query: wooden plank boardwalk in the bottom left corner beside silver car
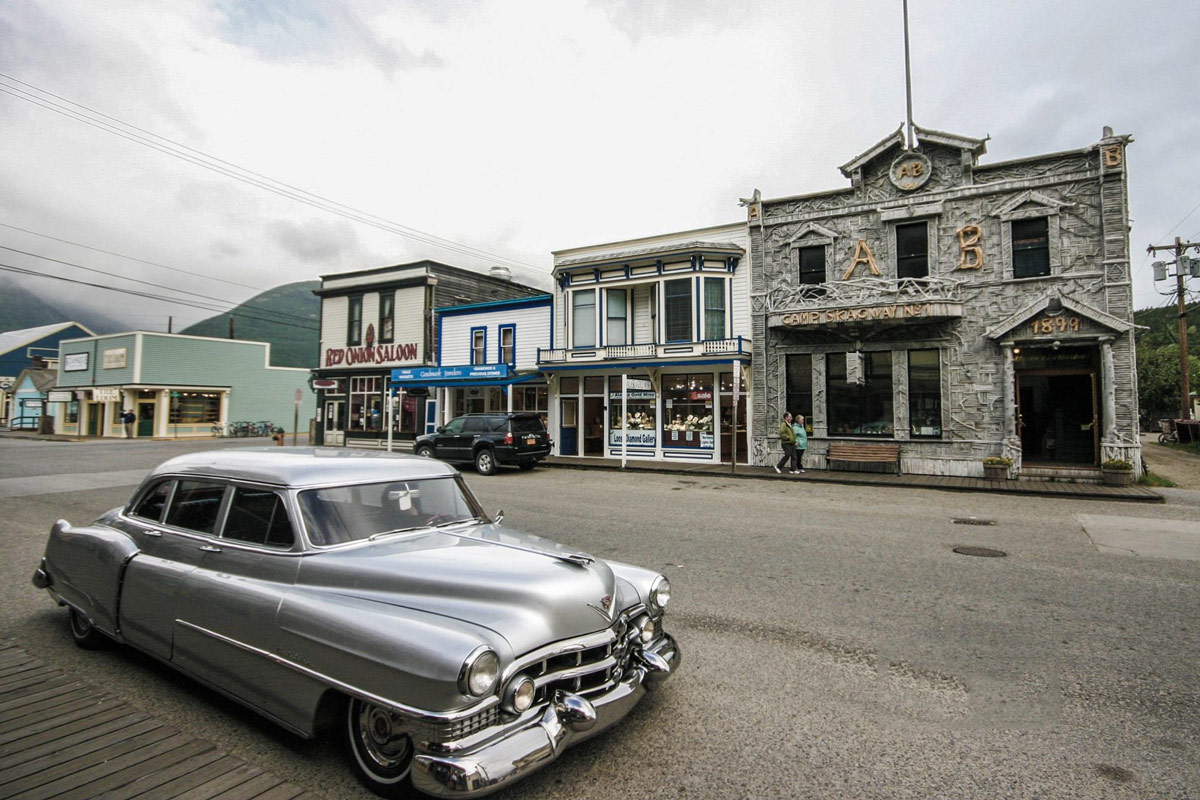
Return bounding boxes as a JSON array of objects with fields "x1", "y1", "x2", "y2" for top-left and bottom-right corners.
[{"x1": 0, "y1": 639, "x2": 322, "y2": 800}]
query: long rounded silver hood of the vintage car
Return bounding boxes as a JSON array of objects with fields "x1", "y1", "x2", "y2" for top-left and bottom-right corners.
[{"x1": 298, "y1": 524, "x2": 619, "y2": 655}]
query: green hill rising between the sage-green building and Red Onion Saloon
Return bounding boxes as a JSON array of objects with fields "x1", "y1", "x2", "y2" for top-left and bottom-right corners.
[{"x1": 180, "y1": 281, "x2": 320, "y2": 368}]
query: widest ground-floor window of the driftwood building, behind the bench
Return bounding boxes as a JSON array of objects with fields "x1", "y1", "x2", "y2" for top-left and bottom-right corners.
[{"x1": 826, "y1": 351, "x2": 894, "y2": 437}]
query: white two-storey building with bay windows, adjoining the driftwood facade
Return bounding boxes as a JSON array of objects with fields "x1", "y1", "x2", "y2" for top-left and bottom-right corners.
[{"x1": 538, "y1": 223, "x2": 751, "y2": 463}]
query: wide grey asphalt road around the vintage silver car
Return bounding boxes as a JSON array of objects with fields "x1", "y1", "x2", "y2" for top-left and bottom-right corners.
[{"x1": 0, "y1": 440, "x2": 1200, "y2": 800}]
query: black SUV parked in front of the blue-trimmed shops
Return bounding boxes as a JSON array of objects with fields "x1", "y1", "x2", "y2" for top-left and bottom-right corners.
[{"x1": 413, "y1": 413, "x2": 550, "y2": 475}]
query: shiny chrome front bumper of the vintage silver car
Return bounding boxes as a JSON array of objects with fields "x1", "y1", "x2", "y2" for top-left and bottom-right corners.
[{"x1": 413, "y1": 636, "x2": 680, "y2": 798}]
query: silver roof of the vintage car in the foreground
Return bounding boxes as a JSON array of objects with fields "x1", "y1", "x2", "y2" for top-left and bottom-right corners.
[{"x1": 141, "y1": 447, "x2": 457, "y2": 488}]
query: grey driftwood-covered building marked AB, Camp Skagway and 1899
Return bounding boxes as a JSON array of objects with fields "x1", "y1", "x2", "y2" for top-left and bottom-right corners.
[{"x1": 744, "y1": 127, "x2": 1140, "y2": 480}]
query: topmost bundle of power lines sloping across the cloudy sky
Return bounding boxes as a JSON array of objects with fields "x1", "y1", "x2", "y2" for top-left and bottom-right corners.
[{"x1": 0, "y1": 73, "x2": 546, "y2": 283}]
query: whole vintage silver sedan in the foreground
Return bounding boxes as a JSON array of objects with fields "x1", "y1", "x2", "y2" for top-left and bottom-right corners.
[{"x1": 34, "y1": 449, "x2": 680, "y2": 798}]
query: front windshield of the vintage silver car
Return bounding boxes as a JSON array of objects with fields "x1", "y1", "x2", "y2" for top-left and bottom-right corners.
[{"x1": 300, "y1": 477, "x2": 481, "y2": 547}]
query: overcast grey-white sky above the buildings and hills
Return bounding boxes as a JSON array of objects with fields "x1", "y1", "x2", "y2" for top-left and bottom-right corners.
[{"x1": 0, "y1": 0, "x2": 1200, "y2": 330}]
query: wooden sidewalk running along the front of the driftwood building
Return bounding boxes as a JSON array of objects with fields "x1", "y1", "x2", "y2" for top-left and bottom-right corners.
[{"x1": 542, "y1": 456, "x2": 1164, "y2": 503}]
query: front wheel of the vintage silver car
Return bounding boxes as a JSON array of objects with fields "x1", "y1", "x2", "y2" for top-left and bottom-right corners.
[{"x1": 346, "y1": 699, "x2": 418, "y2": 798}]
